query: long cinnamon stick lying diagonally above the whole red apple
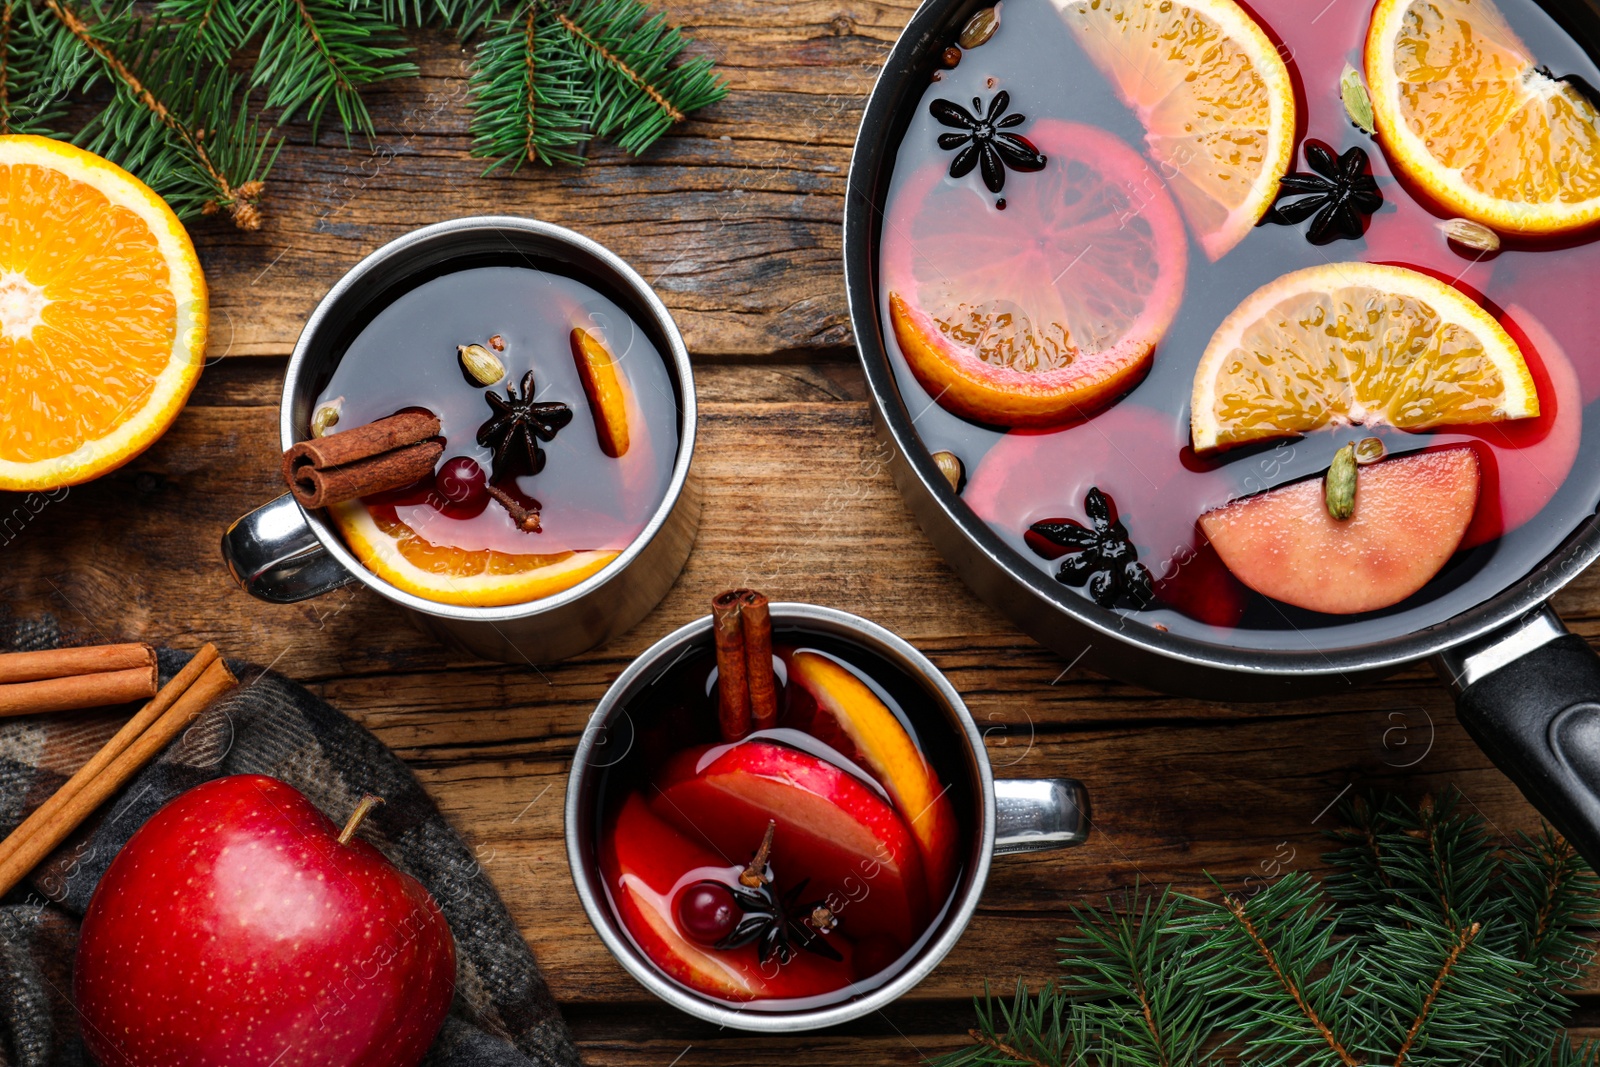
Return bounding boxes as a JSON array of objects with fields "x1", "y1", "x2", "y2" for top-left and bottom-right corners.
[{"x1": 0, "y1": 659, "x2": 238, "y2": 896}]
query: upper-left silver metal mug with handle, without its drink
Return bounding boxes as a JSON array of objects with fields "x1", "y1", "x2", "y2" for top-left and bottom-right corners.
[{"x1": 222, "y1": 216, "x2": 701, "y2": 662}]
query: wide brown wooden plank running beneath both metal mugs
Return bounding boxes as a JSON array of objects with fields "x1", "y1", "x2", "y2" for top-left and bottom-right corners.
[{"x1": 0, "y1": 360, "x2": 1600, "y2": 1036}]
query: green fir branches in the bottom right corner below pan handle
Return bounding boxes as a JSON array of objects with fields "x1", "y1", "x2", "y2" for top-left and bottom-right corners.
[{"x1": 938, "y1": 793, "x2": 1600, "y2": 1067}]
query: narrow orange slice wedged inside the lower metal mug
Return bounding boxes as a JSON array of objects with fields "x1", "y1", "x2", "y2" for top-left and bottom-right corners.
[{"x1": 781, "y1": 649, "x2": 958, "y2": 904}]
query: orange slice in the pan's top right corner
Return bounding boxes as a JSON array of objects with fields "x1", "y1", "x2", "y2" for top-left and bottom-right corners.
[{"x1": 1366, "y1": 0, "x2": 1600, "y2": 234}]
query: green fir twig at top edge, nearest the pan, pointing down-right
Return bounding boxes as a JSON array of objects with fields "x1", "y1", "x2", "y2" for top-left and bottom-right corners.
[{"x1": 555, "y1": 0, "x2": 728, "y2": 155}]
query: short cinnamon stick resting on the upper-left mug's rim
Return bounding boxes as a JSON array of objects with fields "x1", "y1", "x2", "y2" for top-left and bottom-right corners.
[{"x1": 283, "y1": 411, "x2": 445, "y2": 507}]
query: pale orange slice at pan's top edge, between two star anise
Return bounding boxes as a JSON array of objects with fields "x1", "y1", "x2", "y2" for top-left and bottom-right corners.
[{"x1": 1056, "y1": 0, "x2": 1294, "y2": 261}]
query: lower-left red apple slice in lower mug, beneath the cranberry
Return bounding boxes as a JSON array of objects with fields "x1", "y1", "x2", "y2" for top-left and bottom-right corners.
[{"x1": 600, "y1": 793, "x2": 854, "y2": 1001}]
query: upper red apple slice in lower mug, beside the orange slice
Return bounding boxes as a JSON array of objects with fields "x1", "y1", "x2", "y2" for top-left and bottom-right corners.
[{"x1": 650, "y1": 741, "x2": 928, "y2": 945}]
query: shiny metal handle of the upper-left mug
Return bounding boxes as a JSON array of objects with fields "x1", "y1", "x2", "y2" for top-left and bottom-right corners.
[{"x1": 222, "y1": 493, "x2": 355, "y2": 603}]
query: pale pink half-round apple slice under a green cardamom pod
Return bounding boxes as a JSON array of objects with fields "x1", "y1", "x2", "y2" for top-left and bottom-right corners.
[{"x1": 1200, "y1": 448, "x2": 1480, "y2": 614}]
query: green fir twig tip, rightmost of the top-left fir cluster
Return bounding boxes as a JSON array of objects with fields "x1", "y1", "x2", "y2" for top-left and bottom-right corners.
[{"x1": 246, "y1": 0, "x2": 418, "y2": 141}]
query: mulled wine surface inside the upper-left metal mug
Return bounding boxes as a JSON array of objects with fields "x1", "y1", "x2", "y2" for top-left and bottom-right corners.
[{"x1": 314, "y1": 266, "x2": 678, "y2": 553}]
